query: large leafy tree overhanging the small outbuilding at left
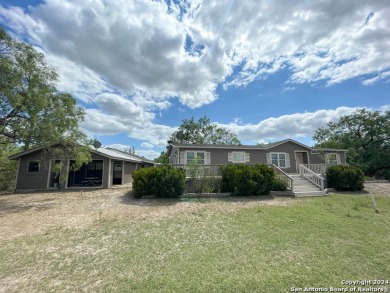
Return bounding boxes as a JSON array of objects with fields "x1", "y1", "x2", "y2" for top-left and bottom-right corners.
[{"x1": 0, "y1": 29, "x2": 86, "y2": 149}]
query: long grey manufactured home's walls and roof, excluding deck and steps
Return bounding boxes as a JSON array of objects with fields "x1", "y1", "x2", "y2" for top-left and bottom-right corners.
[{"x1": 168, "y1": 139, "x2": 347, "y2": 173}]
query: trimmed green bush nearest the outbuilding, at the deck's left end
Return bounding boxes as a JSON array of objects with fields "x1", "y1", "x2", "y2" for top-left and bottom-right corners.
[{"x1": 133, "y1": 166, "x2": 186, "y2": 198}]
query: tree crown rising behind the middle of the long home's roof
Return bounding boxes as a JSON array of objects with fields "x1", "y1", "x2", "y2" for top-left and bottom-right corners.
[{"x1": 170, "y1": 116, "x2": 241, "y2": 145}]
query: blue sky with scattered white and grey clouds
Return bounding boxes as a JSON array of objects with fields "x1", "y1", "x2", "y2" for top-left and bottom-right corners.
[{"x1": 0, "y1": 0, "x2": 390, "y2": 158}]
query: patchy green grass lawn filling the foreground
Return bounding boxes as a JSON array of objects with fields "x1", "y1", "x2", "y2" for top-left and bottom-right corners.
[{"x1": 0, "y1": 195, "x2": 390, "y2": 292}]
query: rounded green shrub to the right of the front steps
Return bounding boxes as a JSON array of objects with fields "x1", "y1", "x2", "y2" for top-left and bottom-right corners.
[{"x1": 326, "y1": 165, "x2": 364, "y2": 191}]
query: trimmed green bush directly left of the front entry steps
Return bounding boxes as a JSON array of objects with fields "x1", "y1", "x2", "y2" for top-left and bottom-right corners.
[{"x1": 221, "y1": 164, "x2": 275, "y2": 196}]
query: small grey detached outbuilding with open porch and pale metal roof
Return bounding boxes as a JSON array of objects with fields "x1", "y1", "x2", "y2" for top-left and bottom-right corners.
[{"x1": 9, "y1": 146, "x2": 154, "y2": 192}]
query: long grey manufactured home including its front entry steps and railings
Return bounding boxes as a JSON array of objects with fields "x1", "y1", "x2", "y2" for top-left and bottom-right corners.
[{"x1": 168, "y1": 139, "x2": 347, "y2": 193}]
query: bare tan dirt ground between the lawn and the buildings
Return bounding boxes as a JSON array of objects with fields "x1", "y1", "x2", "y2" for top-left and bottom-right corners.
[{"x1": 0, "y1": 183, "x2": 390, "y2": 240}]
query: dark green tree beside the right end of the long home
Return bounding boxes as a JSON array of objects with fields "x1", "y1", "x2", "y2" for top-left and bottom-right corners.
[{"x1": 313, "y1": 109, "x2": 390, "y2": 176}]
